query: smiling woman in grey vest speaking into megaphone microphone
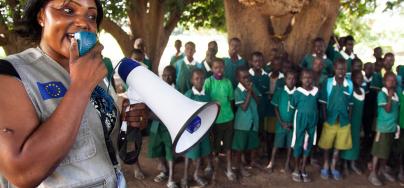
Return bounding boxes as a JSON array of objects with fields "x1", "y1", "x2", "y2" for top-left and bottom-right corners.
[{"x1": 0, "y1": 0, "x2": 146, "y2": 187}]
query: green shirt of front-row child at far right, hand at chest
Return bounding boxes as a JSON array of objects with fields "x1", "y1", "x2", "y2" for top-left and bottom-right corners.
[{"x1": 376, "y1": 87, "x2": 399, "y2": 133}]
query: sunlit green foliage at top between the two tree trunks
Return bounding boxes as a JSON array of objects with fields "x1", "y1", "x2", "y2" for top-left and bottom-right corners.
[{"x1": 179, "y1": 0, "x2": 226, "y2": 32}]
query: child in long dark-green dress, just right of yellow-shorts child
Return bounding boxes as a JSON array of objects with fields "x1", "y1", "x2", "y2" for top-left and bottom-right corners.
[{"x1": 341, "y1": 70, "x2": 365, "y2": 175}]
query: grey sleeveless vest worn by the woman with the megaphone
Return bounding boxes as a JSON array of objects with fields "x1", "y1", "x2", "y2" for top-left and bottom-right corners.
[{"x1": 6, "y1": 48, "x2": 119, "y2": 188}]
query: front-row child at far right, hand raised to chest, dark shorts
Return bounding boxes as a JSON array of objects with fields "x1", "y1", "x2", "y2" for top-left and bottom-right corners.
[{"x1": 368, "y1": 72, "x2": 400, "y2": 186}]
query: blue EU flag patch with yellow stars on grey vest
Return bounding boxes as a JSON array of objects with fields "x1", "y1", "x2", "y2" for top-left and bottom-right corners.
[{"x1": 37, "y1": 82, "x2": 67, "y2": 100}]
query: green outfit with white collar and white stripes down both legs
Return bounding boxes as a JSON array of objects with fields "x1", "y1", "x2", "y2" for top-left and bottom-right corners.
[{"x1": 291, "y1": 87, "x2": 319, "y2": 157}]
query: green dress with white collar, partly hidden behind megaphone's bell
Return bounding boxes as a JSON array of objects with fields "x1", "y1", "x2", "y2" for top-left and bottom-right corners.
[{"x1": 185, "y1": 87, "x2": 212, "y2": 160}]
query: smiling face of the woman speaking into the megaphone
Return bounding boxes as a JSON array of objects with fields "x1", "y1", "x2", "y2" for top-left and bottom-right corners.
[{"x1": 38, "y1": 0, "x2": 97, "y2": 60}]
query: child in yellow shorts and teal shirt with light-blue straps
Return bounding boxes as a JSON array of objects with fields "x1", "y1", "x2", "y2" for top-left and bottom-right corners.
[{"x1": 318, "y1": 58, "x2": 353, "y2": 180}]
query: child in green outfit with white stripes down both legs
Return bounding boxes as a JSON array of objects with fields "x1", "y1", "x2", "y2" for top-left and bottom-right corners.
[{"x1": 291, "y1": 69, "x2": 319, "y2": 182}]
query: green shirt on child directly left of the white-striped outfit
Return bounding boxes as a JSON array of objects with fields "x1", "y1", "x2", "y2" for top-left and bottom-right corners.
[{"x1": 271, "y1": 86, "x2": 296, "y2": 123}]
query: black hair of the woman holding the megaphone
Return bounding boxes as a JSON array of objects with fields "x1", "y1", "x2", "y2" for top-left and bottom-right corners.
[{"x1": 15, "y1": 0, "x2": 104, "y2": 41}]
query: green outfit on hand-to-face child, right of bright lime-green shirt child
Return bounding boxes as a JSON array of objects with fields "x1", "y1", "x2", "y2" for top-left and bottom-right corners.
[{"x1": 232, "y1": 83, "x2": 261, "y2": 151}]
